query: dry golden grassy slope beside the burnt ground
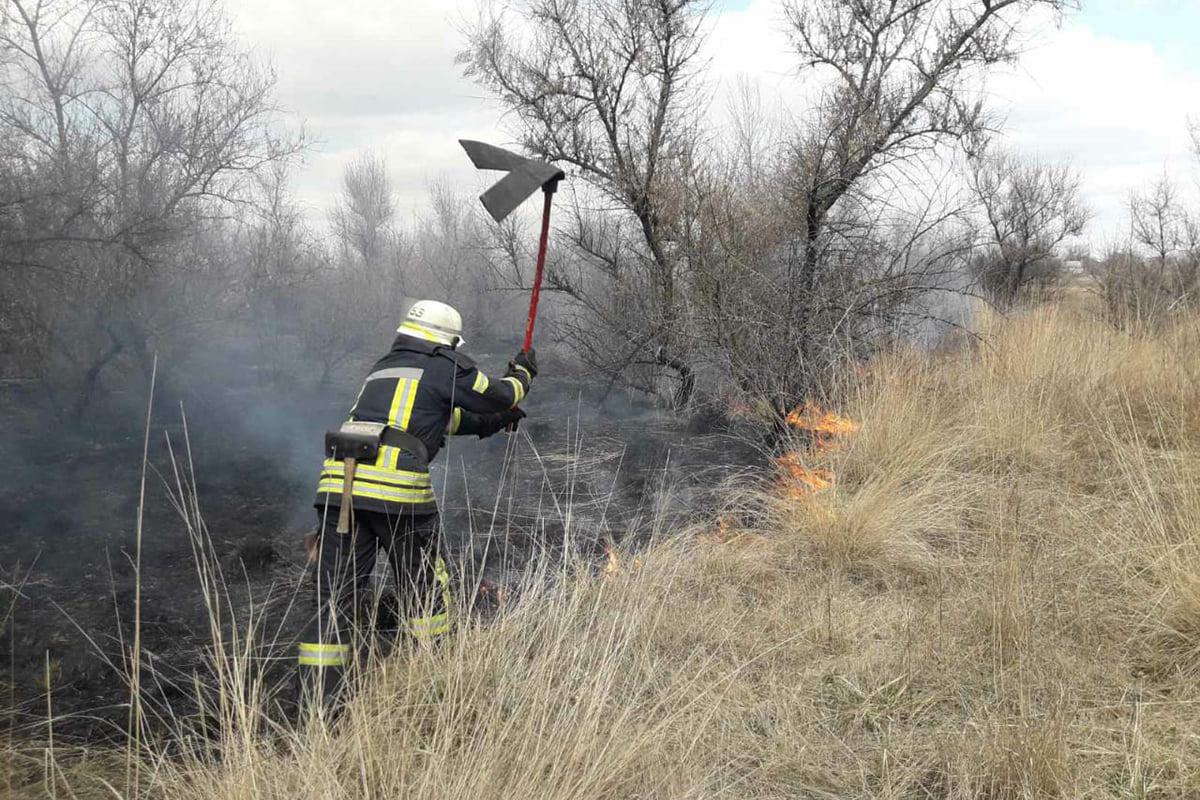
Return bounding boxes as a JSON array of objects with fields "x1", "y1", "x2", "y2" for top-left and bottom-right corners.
[{"x1": 11, "y1": 307, "x2": 1200, "y2": 800}]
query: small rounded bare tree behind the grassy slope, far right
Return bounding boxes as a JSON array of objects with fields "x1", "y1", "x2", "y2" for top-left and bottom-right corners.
[{"x1": 968, "y1": 150, "x2": 1087, "y2": 303}]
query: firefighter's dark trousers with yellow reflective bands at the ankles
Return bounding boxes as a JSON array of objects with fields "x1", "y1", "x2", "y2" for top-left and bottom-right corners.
[{"x1": 299, "y1": 509, "x2": 450, "y2": 708}]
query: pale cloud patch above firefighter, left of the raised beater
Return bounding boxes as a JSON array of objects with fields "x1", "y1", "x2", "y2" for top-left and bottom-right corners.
[{"x1": 228, "y1": 0, "x2": 504, "y2": 219}]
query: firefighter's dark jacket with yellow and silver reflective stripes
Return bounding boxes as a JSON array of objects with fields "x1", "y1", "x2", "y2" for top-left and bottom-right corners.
[{"x1": 316, "y1": 333, "x2": 530, "y2": 513}]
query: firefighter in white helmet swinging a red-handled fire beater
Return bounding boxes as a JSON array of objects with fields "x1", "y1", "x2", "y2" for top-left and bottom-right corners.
[{"x1": 299, "y1": 300, "x2": 538, "y2": 706}]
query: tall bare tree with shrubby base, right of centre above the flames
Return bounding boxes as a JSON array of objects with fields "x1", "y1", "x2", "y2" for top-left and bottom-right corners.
[{"x1": 700, "y1": 0, "x2": 1074, "y2": 416}]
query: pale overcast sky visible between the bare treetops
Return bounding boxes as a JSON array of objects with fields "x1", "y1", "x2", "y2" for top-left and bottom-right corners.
[{"x1": 227, "y1": 0, "x2": 1200, "y2": 243}]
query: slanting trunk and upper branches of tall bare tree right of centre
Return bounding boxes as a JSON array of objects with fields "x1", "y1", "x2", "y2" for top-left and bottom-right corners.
[{"x1": 785, "y1": 0, "x2": 1073, "y2": 341}]
